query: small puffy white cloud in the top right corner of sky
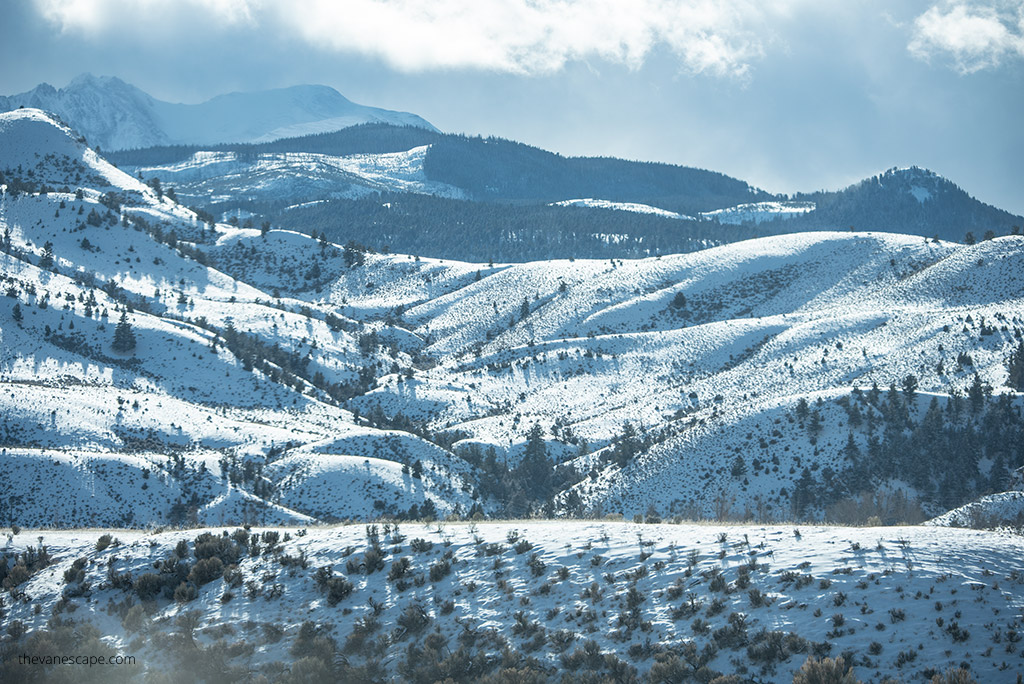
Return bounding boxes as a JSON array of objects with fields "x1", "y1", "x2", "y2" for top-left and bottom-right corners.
[{"x1": 908, "y1": 0, "x2": 1024, "y2": 74}]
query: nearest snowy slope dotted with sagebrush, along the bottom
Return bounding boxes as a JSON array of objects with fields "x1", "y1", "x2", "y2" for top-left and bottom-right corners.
[{"x1": 0, "y1": 521, "x2": 1024, "y2": 682}]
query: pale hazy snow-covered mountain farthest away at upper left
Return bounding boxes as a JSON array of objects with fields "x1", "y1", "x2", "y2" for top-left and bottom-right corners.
[{"x1": 0, "y1": 74, "x2": 435, "y2": 149}]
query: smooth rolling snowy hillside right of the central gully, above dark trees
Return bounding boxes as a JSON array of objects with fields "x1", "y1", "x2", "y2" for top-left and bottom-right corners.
[{"x1": 307, "y1": 233, "x2": 1024, "y2": 518}]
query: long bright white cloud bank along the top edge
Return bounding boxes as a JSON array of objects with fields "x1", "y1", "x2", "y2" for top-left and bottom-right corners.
[{"x1": 29, "y1": 0, "x2": 806, "y2": 76}]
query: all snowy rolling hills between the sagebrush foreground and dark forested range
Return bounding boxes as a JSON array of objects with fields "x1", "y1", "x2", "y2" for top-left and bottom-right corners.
[{"x1": 0, "y1": 110, "x2": 1024, "y2": 525}]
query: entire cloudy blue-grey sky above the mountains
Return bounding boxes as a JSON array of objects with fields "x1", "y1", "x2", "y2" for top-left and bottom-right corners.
[{"x1": 6, "y1": 0, "x2": 1024, "y2": 214}]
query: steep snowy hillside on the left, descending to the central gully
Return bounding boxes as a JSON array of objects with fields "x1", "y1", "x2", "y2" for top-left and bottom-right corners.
[{"x1": 0, "y1": 110, "x2": 471, "y2": 525}]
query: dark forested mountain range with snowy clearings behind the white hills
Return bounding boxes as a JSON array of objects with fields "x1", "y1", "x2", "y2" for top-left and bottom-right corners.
[{"x1": 108, "y1": 124, "x2": 1024, "y2": 254}]
